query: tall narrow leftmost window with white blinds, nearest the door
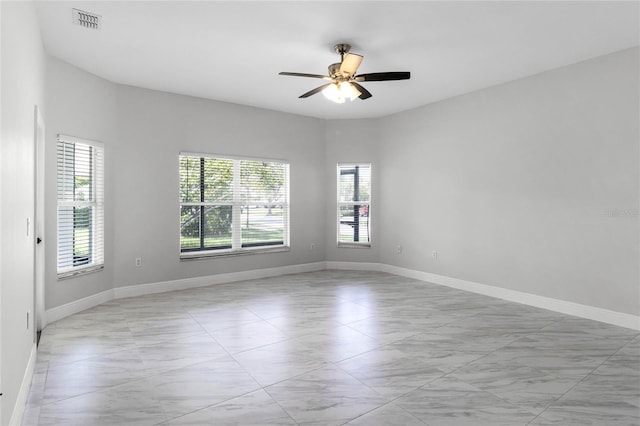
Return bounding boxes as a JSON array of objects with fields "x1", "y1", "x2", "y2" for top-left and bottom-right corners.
[{"x1": 57, "y1": 135, "x2": 104, "y2": 277}]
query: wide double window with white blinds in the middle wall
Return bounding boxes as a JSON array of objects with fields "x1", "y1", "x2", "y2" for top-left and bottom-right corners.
[{"x1": 180, "y1": 153, "x2": 289, "y2": 257}]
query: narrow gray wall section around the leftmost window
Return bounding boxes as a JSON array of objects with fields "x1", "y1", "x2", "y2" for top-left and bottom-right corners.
[{"x1": 44, "y1": 57, "x2": 118, "y2": 309}]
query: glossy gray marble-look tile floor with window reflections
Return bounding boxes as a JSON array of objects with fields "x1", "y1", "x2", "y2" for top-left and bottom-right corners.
[{"x1": 23, "y1": 271, "x2": 640, "y2": 426}]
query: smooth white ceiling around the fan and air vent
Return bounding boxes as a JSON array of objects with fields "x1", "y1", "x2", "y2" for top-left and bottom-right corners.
[{"x1": 37, "y1": 1, "x2": 640, "y2": 118}]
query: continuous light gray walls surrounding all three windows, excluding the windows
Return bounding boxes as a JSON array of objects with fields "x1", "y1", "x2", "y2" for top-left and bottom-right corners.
[{"x1": 42, "y1": 49, "x2": 640, "y2": 315}]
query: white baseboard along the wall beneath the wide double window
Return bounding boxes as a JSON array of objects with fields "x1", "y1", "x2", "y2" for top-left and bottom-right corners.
[{"x1": 113, "y1": 262, "x2": 326, "y2": 299}]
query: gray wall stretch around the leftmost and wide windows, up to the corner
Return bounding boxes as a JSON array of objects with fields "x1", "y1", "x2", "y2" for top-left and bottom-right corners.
[{"x1": 46, "y1": 58, "x2": 325, "y2": 309}]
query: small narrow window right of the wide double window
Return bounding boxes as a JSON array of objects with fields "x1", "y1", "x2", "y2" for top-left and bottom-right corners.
[{"x1": 338, "y1": 164, "x2": 371, "y2": 247}]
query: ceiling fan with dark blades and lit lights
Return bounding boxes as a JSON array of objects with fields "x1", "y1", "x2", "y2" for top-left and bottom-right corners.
[{"x1": 279, "y1": 43, "x2": 411, "y2": 103}]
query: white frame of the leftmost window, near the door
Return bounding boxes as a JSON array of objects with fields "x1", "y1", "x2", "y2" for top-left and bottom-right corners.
[{"x1": 56, "y1": 134, "x2": 105, "y2": 279}]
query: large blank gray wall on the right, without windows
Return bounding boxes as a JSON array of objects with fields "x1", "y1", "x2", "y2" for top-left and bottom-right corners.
[{"x1": 379, "y1": 48, "x2": 640, "y2": 315}]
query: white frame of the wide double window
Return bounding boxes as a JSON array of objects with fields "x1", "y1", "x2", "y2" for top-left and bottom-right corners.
[{"x1": 178, "y1": 152, "x2": 291, "y2": 260}]
